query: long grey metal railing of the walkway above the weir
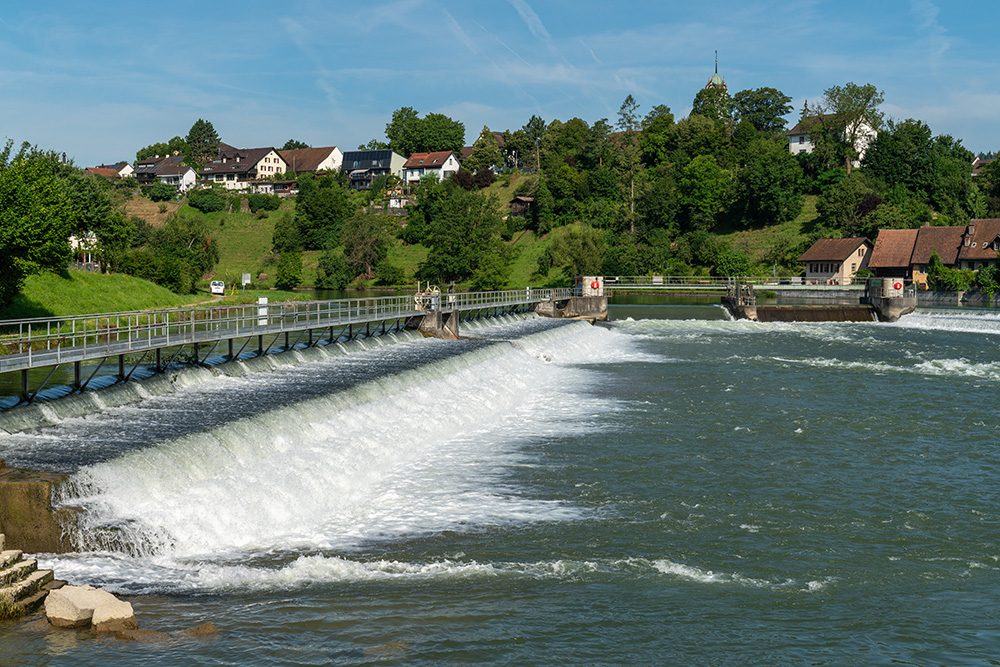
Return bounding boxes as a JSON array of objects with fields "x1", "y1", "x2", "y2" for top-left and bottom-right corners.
[{"x1": 0, "y1": 288, "x2": 572, "y2": 372}]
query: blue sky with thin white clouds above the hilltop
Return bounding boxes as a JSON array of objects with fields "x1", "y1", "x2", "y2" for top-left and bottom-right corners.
[{"x1": 0, "y1": 0, "x2": 1000, "y2": 167}]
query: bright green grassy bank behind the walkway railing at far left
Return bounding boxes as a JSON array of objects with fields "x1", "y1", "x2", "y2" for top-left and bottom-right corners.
[{"x1": 3, "y1": 270, "x2": 193, "y2": 319}]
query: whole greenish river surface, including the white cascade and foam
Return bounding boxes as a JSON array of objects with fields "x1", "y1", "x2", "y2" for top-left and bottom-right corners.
[{"x1": 0, "y1": 305, "x2": 1000, "y2": 666}]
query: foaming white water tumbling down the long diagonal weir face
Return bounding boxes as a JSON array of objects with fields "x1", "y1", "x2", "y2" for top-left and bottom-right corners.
[{"x1": 49, "y1": 325, "x2": 632, "y2": 590}]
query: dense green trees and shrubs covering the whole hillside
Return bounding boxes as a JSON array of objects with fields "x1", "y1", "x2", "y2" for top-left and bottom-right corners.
[{"x1": 0, "y1": 83, "x2": 1000, "y2": 306}]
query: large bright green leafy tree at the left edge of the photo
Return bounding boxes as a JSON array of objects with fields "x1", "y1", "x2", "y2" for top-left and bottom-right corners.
[{"x1": 0, "y1": 141, "x2": 74, "y2": 308}]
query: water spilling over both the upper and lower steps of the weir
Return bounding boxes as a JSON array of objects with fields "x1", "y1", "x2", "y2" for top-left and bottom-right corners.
[{"x1": 15, "y1": 316, "x2": 614, "y2": 587}]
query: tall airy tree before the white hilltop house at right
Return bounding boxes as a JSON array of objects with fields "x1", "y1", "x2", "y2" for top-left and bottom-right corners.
[{"x1": 801, "y1": 82, "x2": 885, "y2": 174}]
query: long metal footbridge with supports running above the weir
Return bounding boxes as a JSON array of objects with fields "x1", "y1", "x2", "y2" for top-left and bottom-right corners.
[{"x1": 0, "y1": 287, "x2": 584, "y2": 407}]
